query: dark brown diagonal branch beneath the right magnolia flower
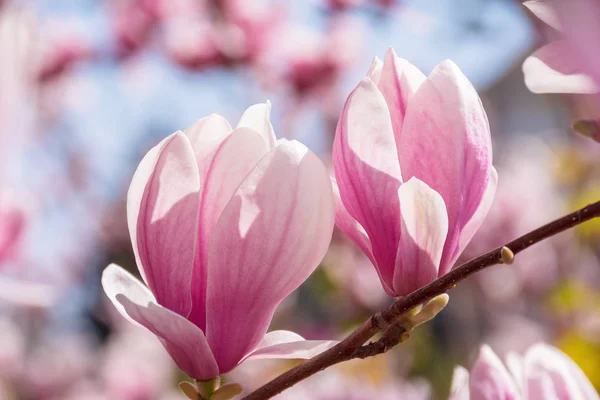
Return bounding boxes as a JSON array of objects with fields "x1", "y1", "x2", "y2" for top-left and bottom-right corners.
[{"x1": 242, "y1": 201, "x2": 600, "y2": 400}]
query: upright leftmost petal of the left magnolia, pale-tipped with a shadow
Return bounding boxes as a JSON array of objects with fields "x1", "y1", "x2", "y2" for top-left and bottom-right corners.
[{"x1": 127, "y1": 132, "x2": 200, "y2": 316}]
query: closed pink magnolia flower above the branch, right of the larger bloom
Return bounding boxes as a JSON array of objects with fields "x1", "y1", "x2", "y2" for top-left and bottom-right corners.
[{"x1": 333, "y1": 49, "x2": 497, "y2": 296}]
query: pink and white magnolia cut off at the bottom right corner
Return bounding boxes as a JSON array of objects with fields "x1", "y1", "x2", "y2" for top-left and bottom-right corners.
[{"x1": 450, "y1": 343, "x2": 600, "y2": 400}]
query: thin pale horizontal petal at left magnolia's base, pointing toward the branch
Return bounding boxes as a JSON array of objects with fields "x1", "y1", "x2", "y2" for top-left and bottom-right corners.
[{"x1": 242, "y1": 340, "x2": 339, "y2": 362}]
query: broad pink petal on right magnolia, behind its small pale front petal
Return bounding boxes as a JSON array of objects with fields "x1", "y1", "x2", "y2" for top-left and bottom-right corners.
[{"x1": 398, "y1": 61, "x2": 492, "y2": 275}]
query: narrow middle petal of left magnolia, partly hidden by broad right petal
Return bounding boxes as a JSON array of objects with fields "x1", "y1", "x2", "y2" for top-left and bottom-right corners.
[{"x1": 189, "y1": 128, "x2": 267, "y2": 329}]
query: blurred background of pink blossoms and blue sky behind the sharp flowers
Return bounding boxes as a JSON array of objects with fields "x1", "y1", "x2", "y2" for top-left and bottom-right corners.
[{"x1": 0, "y1": 0, "x2": 600, "y2": 400}]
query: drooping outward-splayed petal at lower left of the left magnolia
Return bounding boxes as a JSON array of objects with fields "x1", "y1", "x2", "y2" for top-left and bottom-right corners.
[{"x1": 102, "y1": 264, "x2": 219, "y2": 379}]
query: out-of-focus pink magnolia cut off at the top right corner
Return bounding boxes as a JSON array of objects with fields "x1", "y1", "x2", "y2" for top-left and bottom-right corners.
[{"x1": 523, "y1": 0, "x2": 600, "y2": 93}]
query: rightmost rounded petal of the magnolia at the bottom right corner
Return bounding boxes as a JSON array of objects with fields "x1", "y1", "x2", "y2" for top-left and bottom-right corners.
[{"x1": 524, "y1": 343, "x2": 599, "y2": 400}]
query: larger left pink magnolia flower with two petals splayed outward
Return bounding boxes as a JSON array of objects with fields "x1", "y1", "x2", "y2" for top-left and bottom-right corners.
[{"x1": 102, "y1": 103, "x2": 334, "y2": 380}]
